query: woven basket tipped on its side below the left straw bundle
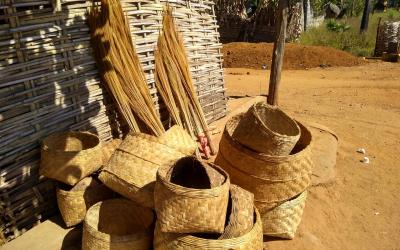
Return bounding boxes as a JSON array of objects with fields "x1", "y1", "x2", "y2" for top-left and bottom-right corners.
[{"x1": 99, "y1": 133, "x2": 190, "y2": 208}]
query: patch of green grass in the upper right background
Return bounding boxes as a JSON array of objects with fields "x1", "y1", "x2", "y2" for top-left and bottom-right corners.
[{"x1": 299, "y1": 10, "x2": 400, "y2": 56}]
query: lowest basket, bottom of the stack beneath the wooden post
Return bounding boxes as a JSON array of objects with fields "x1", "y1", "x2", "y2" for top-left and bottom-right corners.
[{"x1": 255, "y1": 191, "x2": 307, "y2": 239}]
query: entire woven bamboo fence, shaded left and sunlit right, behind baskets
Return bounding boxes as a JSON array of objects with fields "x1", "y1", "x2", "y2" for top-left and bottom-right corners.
[{"x1": 0, "y1": 0, "x2": 226, "y2": 240}]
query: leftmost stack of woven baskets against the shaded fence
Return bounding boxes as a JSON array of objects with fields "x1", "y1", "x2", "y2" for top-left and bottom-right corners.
[{"x1": 40, "y1": 132, "x2": 120, "y2": 227}]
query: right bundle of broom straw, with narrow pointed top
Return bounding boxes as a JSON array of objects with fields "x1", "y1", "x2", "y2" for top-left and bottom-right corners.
[{"x1": 155, "y1": 6, "x2": 215, "y2": 154}]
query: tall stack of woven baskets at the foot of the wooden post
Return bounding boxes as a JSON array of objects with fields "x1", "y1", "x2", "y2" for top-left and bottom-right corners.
[{"x1": 215, "y1": 103, "x2": 313, "y2": 239}]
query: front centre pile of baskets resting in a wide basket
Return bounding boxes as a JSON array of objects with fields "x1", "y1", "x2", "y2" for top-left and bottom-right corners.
[{"x1": 153, "y1": 157, "x2": 263, "y2": 250}]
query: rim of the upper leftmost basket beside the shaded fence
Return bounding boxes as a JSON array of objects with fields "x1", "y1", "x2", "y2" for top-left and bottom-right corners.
[{"x1": 42, "y1": 131, "x2": 101, "y2": 154}]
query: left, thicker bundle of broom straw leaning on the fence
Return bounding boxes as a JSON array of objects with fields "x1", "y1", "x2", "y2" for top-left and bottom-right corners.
[{"x1": 89, "y1": 0, "x2": 164, "y2": 136}]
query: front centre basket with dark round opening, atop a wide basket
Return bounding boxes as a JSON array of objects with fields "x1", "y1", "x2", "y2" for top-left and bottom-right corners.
[{"x1": 154, "y1": 157, "x2": 230, "y2": 233}]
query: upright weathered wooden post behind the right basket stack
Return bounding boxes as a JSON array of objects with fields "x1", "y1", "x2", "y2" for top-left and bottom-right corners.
[{"x1": 267, "y1": 0, "x2": 289, "y2": 105}]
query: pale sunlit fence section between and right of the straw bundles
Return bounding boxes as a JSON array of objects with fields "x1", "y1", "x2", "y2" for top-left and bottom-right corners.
[{"x1": 122, "y1": 0, "x2": 226, "y2": 122}]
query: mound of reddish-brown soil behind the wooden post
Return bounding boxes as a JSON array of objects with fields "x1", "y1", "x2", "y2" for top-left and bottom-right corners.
[{"x1": 222, "y1": 43, "x2": 365, "y2": 69}]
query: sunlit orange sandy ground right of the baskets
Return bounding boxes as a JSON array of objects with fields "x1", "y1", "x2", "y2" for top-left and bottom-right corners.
[{"x1": 225, "y1": 62, "x2": 400, "y2": 249}]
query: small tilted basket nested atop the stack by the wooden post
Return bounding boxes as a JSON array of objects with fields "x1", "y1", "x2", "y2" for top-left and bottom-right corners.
[{"x1": 233, "y1": 102, "x2": 300, "y2": 156}]
